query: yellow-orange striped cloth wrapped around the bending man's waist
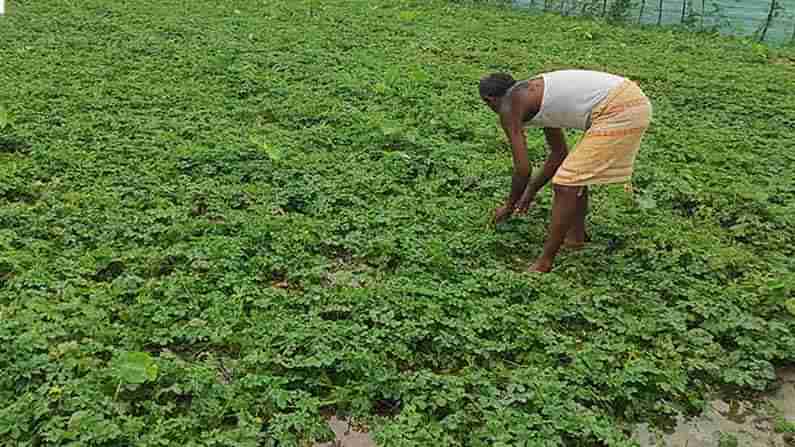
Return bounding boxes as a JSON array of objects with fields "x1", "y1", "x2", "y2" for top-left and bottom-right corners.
[{"x1": 552, "y1": 81, "x2": 652, "y2": 186}]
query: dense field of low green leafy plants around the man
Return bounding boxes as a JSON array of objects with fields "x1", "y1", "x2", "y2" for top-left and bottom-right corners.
[{"x1": 0, "y1": 0, "x2": 795, "y2": 447}]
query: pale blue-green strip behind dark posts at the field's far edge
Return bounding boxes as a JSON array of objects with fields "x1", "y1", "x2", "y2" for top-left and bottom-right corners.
[{"x1": 512, "y1": 0, "x2": 795, "y2": 44}]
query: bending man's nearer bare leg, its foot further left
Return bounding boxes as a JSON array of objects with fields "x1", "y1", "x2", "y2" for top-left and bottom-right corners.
[{"x1": 530, "y1": 185, "x2": 582, "y2": 273}]
